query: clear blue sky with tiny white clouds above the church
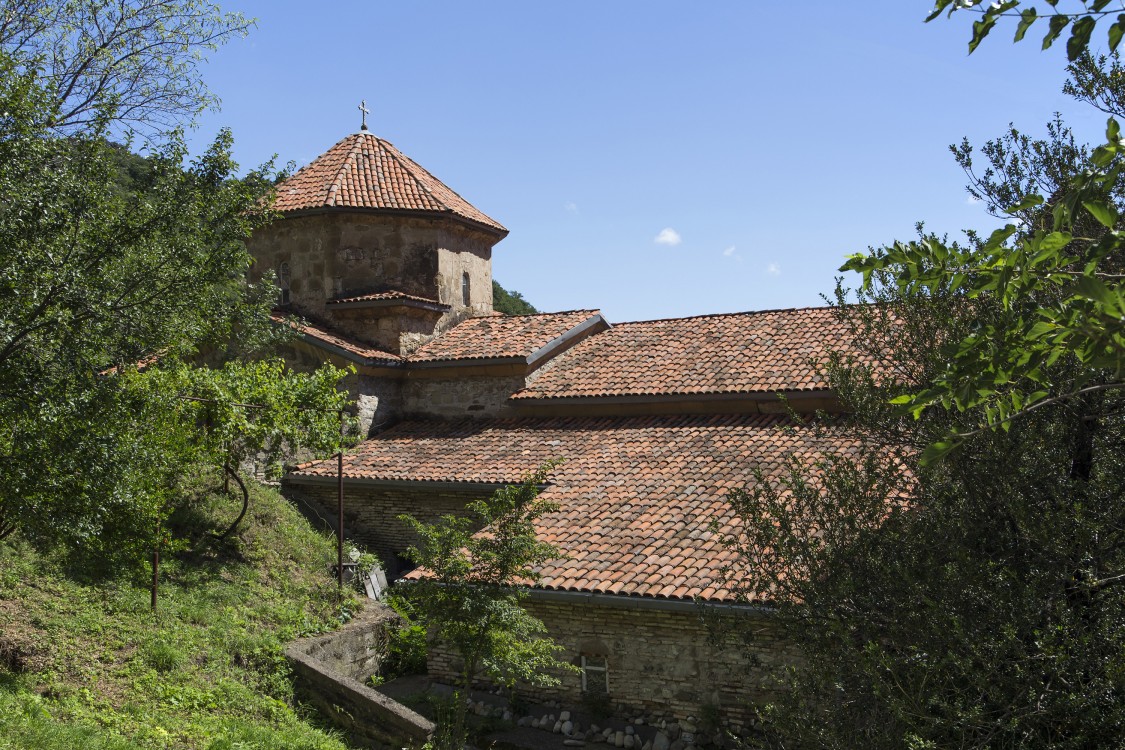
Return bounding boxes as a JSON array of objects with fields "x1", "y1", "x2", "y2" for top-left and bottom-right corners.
[{"x1": 194, "y1": 0, "x2": 1105, "y2": 322}]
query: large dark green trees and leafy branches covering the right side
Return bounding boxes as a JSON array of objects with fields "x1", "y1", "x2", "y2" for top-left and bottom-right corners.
[{"x1": 711, "y1": 13, "x2": 1125, "y2": 748}]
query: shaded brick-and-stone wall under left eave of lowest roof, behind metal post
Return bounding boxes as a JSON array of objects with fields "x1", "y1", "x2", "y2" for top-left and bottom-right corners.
[{"x1": 283, "y1": 484, "x2": 489, "y2": 578}]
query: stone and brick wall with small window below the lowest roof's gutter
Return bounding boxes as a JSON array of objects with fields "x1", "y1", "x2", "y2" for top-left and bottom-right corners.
[{"x1": 429, "y1": 600, "x2": 797, "y2": 725}]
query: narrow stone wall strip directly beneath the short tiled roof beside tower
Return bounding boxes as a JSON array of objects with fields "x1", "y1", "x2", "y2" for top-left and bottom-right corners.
[{"x1": 403, "y1": 376, "x2": 524, "y2": 418}]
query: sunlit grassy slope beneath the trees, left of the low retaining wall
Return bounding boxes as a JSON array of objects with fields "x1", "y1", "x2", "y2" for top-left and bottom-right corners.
[{"x1": 0, "y1": 479, "x2": 356, "y2": 750}]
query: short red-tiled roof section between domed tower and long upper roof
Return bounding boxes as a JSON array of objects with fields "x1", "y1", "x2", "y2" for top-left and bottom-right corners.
[{"x1": 410, "y1": 310, "x2": 601, "y2": 362}]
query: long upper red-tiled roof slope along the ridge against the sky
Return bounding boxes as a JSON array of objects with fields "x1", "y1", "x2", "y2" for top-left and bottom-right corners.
[{"x1": 512, "y1": 307, "x2": 847, "y2": 400}]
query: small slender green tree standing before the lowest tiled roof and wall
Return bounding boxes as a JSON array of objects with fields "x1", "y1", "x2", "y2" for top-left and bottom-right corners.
[{"x1": 399, "y1": 463, "x2": 572, "y2": 750}]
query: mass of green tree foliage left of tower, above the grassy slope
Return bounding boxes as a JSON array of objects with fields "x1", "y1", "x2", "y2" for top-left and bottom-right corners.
[{"x1": 0, "y1": 5, "x2": 343, "y2": 562}]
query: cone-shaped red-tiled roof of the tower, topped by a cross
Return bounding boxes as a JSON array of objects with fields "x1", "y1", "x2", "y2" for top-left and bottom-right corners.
[{"x1": 273, "y1": 130, "x2": 507, "y2": 237}]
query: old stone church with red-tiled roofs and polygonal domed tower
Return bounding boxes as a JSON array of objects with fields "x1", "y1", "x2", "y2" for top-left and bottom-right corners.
[{"x1": 251, "y1": 122, "x2": 846, "y2": 721}]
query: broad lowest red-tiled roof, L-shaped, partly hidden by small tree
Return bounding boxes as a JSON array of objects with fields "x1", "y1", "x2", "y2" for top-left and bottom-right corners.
[{"x1": 293, "y1": 415, "x2": 855, "y2": 602}]
